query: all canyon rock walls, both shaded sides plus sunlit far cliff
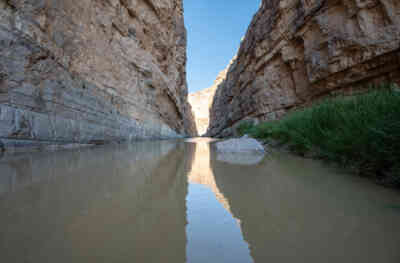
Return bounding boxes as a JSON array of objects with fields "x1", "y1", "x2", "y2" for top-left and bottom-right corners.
[{"x1": 0, "y1": 0, "x2": 400, "y2": 144}]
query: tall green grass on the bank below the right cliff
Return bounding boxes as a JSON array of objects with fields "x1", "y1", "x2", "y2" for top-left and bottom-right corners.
[{"x1": 238, "y1": 85, "x2": 400, "y2": 186}]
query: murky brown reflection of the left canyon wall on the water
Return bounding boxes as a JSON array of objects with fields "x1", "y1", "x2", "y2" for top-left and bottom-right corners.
[{"x1": 0, "y1": 142, "x2": 192, "y2": 263}]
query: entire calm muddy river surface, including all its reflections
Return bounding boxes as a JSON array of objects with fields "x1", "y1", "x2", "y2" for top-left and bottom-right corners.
[{"x1": 0, "y1": 139, "x2": 400, "y2": 263}]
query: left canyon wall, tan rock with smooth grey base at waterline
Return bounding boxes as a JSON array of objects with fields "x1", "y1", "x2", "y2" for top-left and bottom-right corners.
[{"x1": 0, "y1": 0, "x2": 194, "y2": 148}]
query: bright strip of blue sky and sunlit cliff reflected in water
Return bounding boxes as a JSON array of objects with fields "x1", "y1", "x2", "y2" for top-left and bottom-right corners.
[{"x1": 186, "y1": 138, "x2": 252, "y2": 263}]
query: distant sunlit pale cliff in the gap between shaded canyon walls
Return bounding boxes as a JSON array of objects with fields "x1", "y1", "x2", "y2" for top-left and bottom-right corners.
[{"x1": 189, "y1": 68, "x2": 228, "y2": 135}]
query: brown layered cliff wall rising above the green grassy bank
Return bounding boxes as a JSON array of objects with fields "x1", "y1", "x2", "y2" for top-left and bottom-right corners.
[{"x1": 208, "y1": 0, "x2": 400, "y2": 136}]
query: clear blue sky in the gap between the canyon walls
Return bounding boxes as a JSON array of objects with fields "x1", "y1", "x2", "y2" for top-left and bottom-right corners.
[{"x1": 183, "y1": 0, "x2": 260, "y2": 92}]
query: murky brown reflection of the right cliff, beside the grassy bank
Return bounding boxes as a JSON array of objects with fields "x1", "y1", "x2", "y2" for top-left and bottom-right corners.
[{"x1": 211, "y1": 154, "x2": 400, "y2": 263}]
